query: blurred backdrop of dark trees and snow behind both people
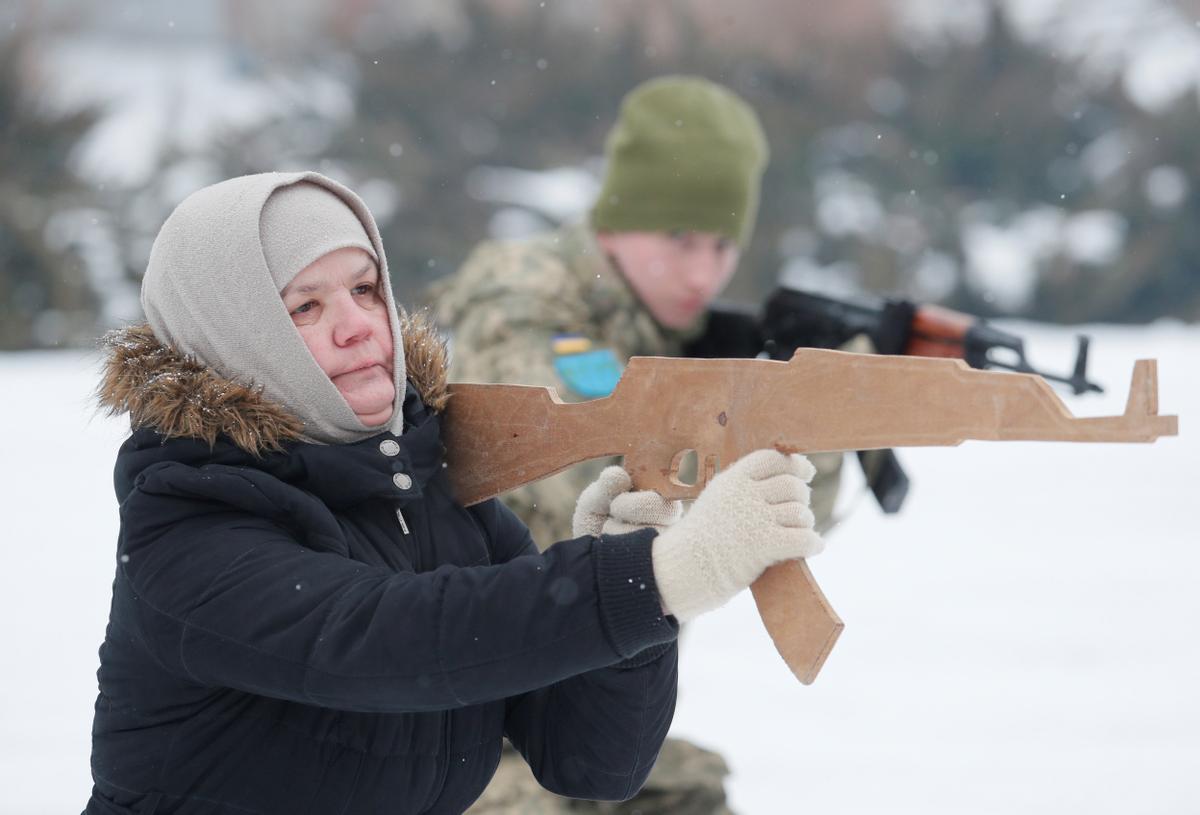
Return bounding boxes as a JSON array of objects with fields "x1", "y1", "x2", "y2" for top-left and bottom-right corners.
[{"x1": 7, "y1": 0, "x2": 1200, "y2": 349}]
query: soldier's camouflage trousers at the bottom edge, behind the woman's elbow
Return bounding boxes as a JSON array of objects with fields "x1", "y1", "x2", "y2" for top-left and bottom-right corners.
[{"x1": 467, "y1": 738, "x2": 732, "y2": 815}]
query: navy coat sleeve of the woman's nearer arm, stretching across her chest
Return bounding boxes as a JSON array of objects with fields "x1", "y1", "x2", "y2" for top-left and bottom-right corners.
[{"x1": 114, "y1": 471, "x2": 676, "y2": 713}]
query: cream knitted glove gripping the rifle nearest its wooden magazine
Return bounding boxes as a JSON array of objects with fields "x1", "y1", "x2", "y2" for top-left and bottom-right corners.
[{"x1": 652, "y1": 450, "x2": 824, "y2": 622}]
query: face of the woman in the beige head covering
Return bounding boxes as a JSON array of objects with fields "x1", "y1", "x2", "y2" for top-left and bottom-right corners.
[{"x1": 280, "y1": 248, "x2": 396, "y2": 427}]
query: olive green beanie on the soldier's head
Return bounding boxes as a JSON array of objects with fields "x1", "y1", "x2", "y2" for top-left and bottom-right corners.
[{"x1": 592, "y1": 77, "x2": 768, "y2": 246}]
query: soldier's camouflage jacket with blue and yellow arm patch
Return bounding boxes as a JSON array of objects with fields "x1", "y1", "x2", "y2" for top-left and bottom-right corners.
[{"x1": 436, "y1": 226, "x2": 841, "y2": 549}]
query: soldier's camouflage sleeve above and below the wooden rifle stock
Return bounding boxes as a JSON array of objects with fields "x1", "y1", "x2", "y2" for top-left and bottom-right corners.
[{"x1": 437, "y1": 238, "x2": 612, "y2": 550}]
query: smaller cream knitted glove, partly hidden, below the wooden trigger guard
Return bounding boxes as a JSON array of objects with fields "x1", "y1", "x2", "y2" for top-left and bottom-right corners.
[{"x1": 571, "y1": 466, "x2": 683, "y2": 538}]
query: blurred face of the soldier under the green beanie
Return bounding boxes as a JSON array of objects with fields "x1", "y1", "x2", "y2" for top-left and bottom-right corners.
[{"x1": 596, "y1": 232, "x2": 739, "y2": 329}]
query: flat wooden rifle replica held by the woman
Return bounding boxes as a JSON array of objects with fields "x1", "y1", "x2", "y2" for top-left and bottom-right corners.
[{"x1": 443, "y1": 348, "x2": 1178, "y2": 684}]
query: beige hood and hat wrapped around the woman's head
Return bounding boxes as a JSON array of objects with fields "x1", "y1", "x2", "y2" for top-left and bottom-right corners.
[{"x1": 142, "y1": 173, "x2": 406, "y2": 444}]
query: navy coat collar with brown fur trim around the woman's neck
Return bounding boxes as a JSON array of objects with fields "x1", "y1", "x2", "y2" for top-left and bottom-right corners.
[{"x1": 97, "y1": 316, "x2": 449, "y2": 508}]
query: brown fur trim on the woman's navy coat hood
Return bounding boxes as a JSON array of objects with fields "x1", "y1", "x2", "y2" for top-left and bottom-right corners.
[{"x1": 96, "y1": 312, "x2": 449, "y2": 456}]
